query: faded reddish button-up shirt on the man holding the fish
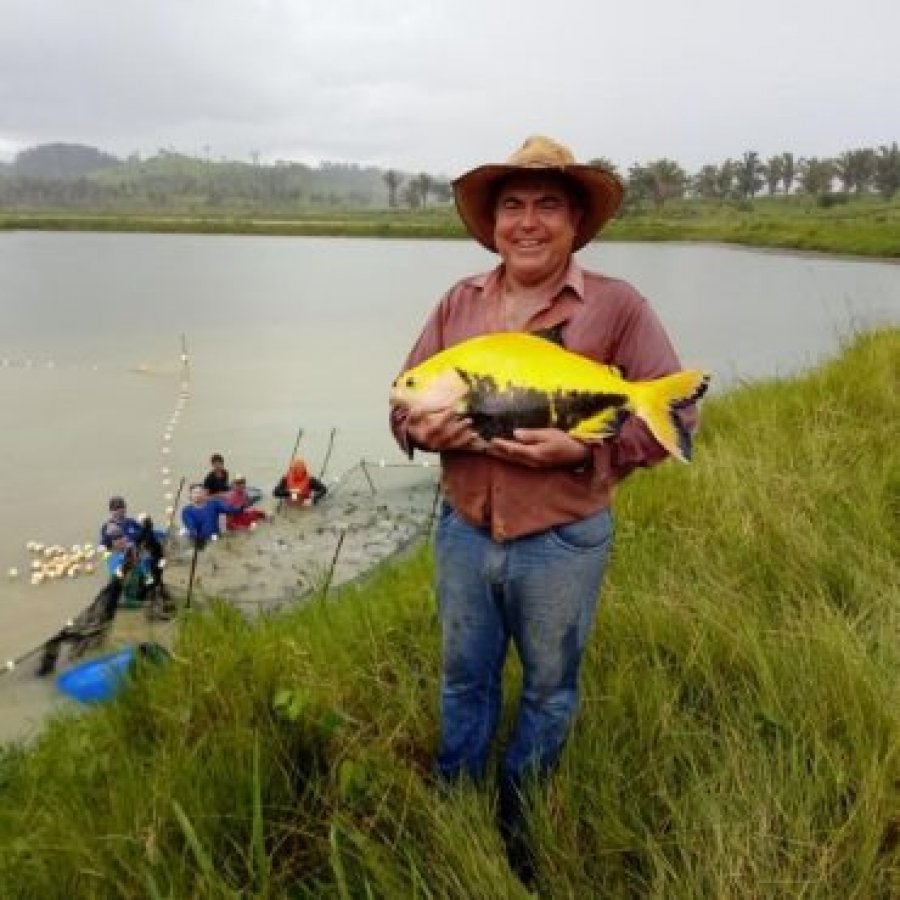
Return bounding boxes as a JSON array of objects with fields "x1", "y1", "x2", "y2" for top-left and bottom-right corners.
[{"x1": 391, "y1": 260, "x2": 696, "y2": 541}]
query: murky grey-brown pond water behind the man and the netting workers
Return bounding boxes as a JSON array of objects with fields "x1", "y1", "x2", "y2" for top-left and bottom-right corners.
[{"x1": 0, "y1": 232, "x2": 900, "y2": 684}]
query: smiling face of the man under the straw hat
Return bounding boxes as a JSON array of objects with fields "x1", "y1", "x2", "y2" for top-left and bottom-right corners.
[{"x1": 494, "y1": 174, "x2": 581, "y2": 285}]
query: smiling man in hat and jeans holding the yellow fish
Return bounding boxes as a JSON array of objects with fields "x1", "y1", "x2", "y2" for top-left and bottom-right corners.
[{"x1": 391, "y1": 137, "x2": 695, "y2": 881}]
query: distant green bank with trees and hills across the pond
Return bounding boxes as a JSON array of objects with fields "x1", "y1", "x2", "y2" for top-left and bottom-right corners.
[{"x1": 0, "y1": 142, "x2": 900, "y2": 257}]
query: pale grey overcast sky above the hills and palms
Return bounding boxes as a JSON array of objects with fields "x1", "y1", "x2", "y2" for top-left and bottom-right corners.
[{"x1": 0, "y1": 0, "x2": 900, "y2": 176}]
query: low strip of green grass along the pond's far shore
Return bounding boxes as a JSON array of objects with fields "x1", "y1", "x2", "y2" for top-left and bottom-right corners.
[{"x1": 0, "y1": 197, "x2": 900, "y2": 258}]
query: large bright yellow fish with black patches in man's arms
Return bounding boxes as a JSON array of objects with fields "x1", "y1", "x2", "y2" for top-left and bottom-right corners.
[{"x1": 390, "y1": 332, "x2": 710, "y2": 462}]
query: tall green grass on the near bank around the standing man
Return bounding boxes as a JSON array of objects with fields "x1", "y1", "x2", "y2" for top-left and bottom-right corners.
[{"x1": 0, "y1": 329, "x2": 900, "y2": 898}]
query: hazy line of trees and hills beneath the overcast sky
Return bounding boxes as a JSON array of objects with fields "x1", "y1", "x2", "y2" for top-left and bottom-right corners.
[{"x1": 0, "y1": 141, "x2": 900, "y2": 214}]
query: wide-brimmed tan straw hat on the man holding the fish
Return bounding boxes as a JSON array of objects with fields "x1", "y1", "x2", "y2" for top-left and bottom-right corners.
[{"x1": 453, "y1": 135, "x2": 625, "y2": 253}]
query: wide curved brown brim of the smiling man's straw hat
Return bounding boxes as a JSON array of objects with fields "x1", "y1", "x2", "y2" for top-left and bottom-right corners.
[{"x1": 453, "y1": 163, "x2": 625, "y2": 253}]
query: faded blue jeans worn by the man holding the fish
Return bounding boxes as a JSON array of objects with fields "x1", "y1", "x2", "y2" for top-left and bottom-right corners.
[{"x1": 436, "y1": 503, "x2": 613, "y2": 780}]
